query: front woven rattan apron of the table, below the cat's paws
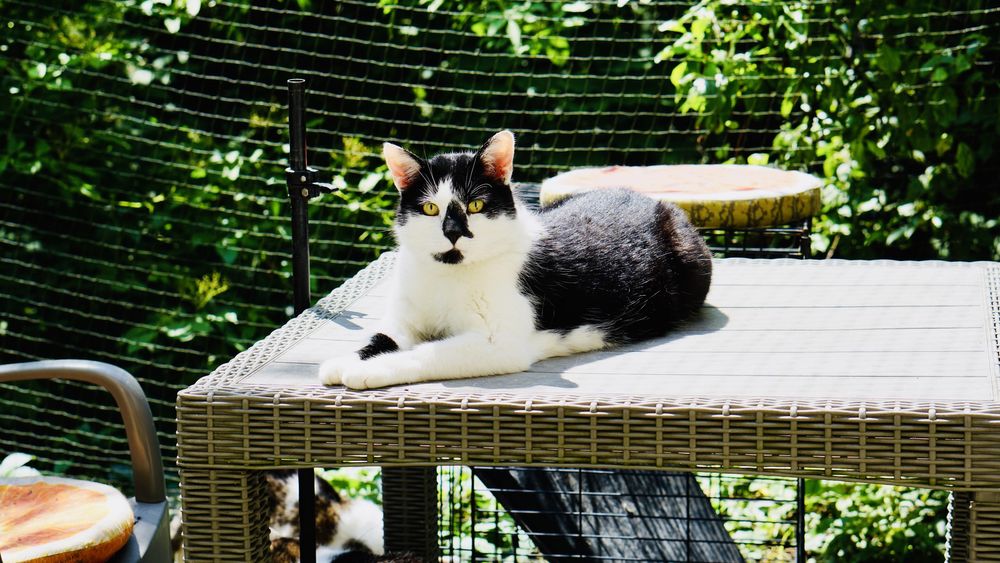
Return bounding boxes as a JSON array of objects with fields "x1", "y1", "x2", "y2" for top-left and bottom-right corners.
[{"x1": 178, "y1": 393, "x2": 1000, "y2": 491}]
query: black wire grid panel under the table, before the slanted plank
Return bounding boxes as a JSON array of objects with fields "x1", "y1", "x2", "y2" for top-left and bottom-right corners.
[{"x1": 438, "y1": 467, "x2": 799, "y2": 562}]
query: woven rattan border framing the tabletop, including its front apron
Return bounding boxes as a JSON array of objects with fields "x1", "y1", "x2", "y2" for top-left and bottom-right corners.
[{"x1": 177, "y1": 254, "x2": 1000, "y2": 491}]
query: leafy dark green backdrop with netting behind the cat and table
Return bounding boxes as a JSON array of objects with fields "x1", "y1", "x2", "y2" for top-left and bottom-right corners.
[{"x1": 0, "y1": 0, "x2": 1000, "y2": 561}]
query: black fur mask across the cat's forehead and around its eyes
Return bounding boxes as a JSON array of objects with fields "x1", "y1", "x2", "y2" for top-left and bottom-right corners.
[{"x1": 396, "y1": 152, "x2": 516, "y2": 228}]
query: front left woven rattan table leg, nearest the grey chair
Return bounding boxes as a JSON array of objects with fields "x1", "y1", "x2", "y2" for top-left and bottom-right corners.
[{"x1": 180, "y1": 469, "x2": 271, "y2": 563}]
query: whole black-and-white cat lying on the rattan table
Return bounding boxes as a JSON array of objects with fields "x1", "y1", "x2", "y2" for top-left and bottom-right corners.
[{"x1": 319, "y1": 131, "x2": 712, "y2": 389}]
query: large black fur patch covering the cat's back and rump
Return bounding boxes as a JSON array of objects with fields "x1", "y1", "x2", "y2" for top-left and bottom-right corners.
[{"x1": 521, "y1": 189, "x2": 712, "y2": 344}]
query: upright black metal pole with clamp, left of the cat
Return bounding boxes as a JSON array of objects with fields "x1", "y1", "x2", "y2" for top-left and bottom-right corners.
[{"x1": 286, "y1": 78, "x2": 316, "y2": 563}]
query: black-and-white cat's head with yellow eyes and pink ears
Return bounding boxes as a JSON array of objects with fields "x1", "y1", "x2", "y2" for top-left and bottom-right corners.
[{"x1": 382, "y1": 131, "x2": 517, "y2": 264}]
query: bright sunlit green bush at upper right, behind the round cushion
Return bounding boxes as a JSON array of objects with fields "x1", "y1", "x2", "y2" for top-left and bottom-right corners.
[{"x1": 657, "y1": 0, "x2": 1000, "y2": 260}]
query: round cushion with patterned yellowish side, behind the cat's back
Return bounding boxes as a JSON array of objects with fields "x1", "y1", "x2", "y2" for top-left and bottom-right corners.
[{"x1": 540, "y1": 164, "x2": 822, "y2": 229}]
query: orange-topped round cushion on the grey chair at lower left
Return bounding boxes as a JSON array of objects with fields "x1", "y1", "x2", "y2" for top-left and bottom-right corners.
[{"x1": 0, "y1": 477, "x2": 135, "y2": 563}]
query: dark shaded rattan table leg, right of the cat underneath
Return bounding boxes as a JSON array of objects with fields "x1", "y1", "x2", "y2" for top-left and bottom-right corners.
[{"x1": 382, "y1": 467, "x2": 438, "y2": 561}]
